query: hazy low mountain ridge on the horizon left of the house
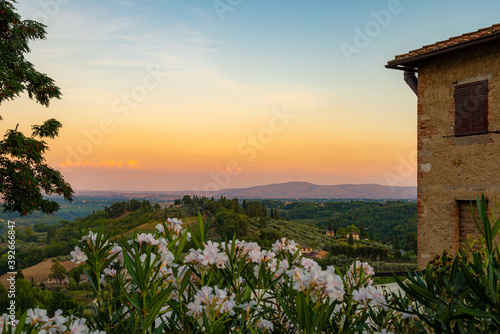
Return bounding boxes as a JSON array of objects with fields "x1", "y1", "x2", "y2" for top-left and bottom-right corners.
[{"x1": 178, "y1": 182, "x2": 417, "y2": 199}]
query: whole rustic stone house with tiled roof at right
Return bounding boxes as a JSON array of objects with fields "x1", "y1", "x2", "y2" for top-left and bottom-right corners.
[{"x1": 386, "y1": 24, "x2": 500, "y2": 267}]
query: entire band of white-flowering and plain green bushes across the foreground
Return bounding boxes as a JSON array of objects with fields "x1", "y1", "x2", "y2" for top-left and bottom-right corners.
[{"x1": 6, "y1": 197, "x2": 500, "y2": 334}]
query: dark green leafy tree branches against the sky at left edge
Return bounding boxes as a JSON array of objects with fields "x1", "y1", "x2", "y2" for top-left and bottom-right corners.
[{"x1": 0, "y1": 0, "x2": 73, "y2": 216}]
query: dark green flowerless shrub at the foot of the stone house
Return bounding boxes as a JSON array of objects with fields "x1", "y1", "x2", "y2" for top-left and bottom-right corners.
[{"x1": 397, "y1": 195, "x2": 500, "y2": 333}]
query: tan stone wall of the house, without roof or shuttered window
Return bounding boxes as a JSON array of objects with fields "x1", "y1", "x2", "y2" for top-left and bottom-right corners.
[{"x1": 417, "y1": 42, "x2": 500, "y2": 267}]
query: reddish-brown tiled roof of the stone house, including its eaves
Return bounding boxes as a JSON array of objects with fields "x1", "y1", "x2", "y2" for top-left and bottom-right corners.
[{"x1": 386, "y1": 24, "x2": 500, "y2": 68}]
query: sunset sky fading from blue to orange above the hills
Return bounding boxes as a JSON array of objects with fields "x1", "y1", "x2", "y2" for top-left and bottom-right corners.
[{"x1": 0, "y1": 0, "x2": 500, "y2": 191}]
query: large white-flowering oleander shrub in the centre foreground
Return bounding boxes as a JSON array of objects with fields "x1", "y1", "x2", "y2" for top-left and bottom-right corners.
[{"x1": 62, "y1": 217, "x2": 411, "y2": 333}]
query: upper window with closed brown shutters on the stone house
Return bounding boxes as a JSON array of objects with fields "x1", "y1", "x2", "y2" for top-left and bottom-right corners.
[{"x1": 455, "y1": 80, "x2": 488, "y2": 136}]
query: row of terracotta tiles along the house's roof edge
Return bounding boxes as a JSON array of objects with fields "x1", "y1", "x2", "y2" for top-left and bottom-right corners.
[{"x1": 388, "y1": 23, "x2": 500, "y2": 65}]
